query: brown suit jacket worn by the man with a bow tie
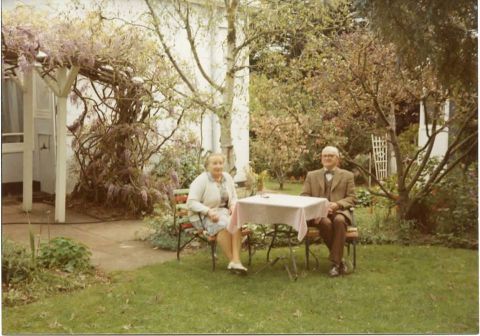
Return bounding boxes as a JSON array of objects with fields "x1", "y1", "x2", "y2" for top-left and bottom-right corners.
[{"x1": 301, "y1": 168, "x2": 355, "y2": 222}]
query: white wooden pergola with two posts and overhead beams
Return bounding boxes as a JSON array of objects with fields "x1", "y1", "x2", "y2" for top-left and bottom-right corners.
[{"x1": 2, "y1": 49, "x2": 152, "y2": 223}]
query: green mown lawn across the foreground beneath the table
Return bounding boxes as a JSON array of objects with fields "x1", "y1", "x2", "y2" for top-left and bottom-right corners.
[{"x1": 3, "y1": 245, "x2": 479, "y2": 334}]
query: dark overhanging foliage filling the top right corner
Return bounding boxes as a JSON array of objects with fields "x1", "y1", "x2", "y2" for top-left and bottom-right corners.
[{"x1": 355, "y1": 0, "x2": 478, "y2": 89}]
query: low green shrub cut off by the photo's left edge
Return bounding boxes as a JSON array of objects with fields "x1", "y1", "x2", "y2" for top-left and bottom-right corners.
[{"x1": 2, "y1": 239, "x2": 35, "y2": 286}]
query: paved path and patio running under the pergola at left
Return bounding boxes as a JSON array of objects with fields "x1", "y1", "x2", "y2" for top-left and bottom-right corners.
[{"x1": 2, "y1": 201, "x2": 176, "y2": 271}]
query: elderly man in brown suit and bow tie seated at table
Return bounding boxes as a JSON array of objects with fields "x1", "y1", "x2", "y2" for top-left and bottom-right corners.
[{"x1": 302, "y1": 146, "x2": 355, "y2": 277}]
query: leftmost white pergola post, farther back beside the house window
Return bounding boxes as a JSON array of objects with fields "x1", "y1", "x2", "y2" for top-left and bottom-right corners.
[{"x1": 22, "y1": 70, "x2": 34, "y2": 211}]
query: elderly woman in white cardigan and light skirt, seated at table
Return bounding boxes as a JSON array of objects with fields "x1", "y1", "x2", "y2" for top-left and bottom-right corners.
[{"x1": 187, "y1": 154, "x2": 247, "y2": 273}]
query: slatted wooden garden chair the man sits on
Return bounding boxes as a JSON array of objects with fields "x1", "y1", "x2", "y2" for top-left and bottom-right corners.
[{"x1": 305, "y1": 207, "x2": 359, "y2": 270}]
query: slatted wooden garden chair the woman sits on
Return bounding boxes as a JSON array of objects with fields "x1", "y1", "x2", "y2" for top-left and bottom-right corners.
[{"x1": 173, "y1": 189, "x2": 252, "y2": 271}]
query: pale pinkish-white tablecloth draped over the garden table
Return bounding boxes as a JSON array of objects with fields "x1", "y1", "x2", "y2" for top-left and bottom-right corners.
[{"x1": 227, "y1": 194, "x2": 328, "y2": 241}]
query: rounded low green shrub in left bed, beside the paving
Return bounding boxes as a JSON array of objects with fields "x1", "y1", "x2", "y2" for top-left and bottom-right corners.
[{"x1": 38, "y1": 237, "x2": 92, "y2": 273}]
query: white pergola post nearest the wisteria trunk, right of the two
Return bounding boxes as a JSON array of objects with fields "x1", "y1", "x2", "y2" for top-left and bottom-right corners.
[{"x1": 55, "y1": 68, "x2": 67, "y2": 223}]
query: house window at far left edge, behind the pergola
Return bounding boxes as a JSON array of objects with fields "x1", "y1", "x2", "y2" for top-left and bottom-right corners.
[{"x1": 2, "y1": 78, "x2": 23, "y2": 144}]
